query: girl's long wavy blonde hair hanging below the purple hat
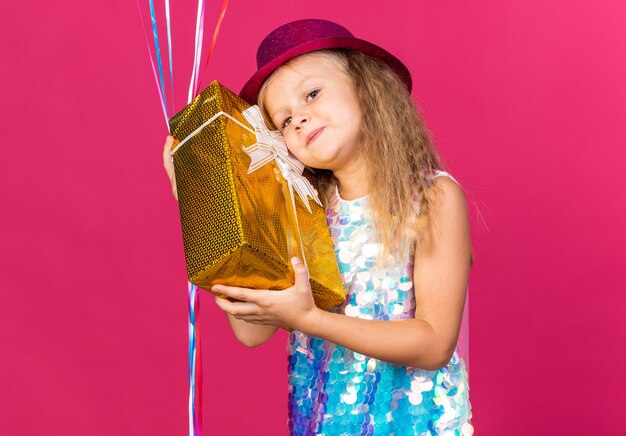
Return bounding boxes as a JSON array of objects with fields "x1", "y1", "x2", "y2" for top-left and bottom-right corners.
[{"x1": 258, "y1": 49, "x2": 443, "y2": 255}]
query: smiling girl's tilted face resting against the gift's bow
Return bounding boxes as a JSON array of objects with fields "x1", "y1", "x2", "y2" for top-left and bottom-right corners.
[{"x1": 265, "y1": 53, "x2": 361, "y2": 171}]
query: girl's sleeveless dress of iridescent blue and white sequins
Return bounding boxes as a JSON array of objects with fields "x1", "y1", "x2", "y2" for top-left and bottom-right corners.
[{"x1": 288, "y1": 172, "x2": 473, "y2": 436}]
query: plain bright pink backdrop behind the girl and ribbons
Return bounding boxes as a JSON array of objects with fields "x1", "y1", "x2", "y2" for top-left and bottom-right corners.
[{"x1": 0, "y1": 0, "x2": 626, "y2": 435}]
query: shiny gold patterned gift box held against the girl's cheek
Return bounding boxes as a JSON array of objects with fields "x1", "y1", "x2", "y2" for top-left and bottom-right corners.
[{"x1": 170, "y1": 81, "x2": 345, "y2": 309}]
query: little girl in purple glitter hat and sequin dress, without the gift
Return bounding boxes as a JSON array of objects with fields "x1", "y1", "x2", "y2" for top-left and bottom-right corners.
[{"x1": 164, "y1": 20, "x2": 473, "y2": 435}]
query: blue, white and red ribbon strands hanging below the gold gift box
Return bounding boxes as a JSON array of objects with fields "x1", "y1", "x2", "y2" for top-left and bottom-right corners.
[{"x1": 187, "y1": 283, "x2": 202, "y2": 436}]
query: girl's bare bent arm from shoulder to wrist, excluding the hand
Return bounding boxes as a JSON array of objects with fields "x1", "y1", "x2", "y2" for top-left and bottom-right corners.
[{"x1": 304, "y1": 177, "x2": 471, "y2": 370}]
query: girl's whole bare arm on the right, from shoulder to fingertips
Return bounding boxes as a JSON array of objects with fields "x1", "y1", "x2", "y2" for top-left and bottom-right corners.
[{"x1": 214, "y1": 177, "x2": 471, "y2": 370}]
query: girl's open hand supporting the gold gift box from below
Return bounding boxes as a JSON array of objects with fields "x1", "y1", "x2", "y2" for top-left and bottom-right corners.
[{"x1": 212, "y1": 257, "x2": 320, "y2": 330}]
